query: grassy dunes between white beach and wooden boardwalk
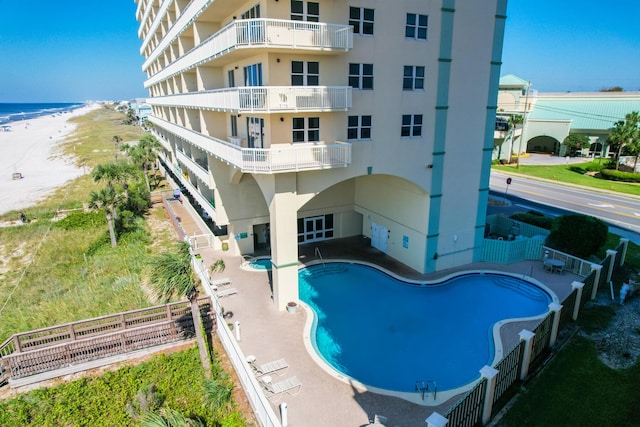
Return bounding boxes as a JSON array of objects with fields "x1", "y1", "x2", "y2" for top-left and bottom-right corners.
[{"x1": 0, "y1": 108, "x2": 152, "y2": 342}]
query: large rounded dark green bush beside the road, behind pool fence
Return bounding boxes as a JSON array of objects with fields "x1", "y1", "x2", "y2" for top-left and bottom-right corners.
[{"x1": 547, "y1": 214, "x2": 609, "y2": 258}]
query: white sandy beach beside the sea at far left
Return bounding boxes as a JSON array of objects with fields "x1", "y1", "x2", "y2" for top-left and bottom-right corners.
[{"x1": 0, "y1": 104, "x2": 100, "y2": 214}]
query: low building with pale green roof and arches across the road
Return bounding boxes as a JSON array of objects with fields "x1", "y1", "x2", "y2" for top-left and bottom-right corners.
[{"x1": 494, "y1": 74, "x2": 640, "y2": 160}]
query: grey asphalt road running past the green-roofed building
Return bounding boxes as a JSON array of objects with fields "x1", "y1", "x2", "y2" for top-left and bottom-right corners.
[{"x1": 488, "y1": 156, "x2": 640, "y2": 243}]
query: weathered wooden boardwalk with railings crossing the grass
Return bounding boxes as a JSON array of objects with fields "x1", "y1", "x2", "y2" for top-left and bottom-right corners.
[{"x1": 0, "y1": 297, "x2": 215, "y2": 385}]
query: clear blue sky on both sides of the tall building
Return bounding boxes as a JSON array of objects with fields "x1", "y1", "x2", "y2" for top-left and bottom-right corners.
[{"x1": 0, "y1": 0, "x2": 640, "y2": 102}]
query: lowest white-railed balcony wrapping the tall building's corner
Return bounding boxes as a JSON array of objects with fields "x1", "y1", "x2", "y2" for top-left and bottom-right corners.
[{"x1": 149, "y1": 116, "x2": 351, "y2": 174}]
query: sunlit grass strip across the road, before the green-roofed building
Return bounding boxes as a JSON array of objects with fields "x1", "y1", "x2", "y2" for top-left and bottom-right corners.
[{"x1": 492, "y1": 165, "x2": 640, "y2": 195}]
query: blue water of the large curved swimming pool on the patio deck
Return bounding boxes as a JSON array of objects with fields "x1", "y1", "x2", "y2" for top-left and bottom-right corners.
[{"x1": 299, "y1": 263, "x2": 552, "y2": 392}]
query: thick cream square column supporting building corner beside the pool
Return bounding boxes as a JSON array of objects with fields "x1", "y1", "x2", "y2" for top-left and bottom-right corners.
[{"x1": 269, "y1": 173, "x2": 298, "y2": 311}]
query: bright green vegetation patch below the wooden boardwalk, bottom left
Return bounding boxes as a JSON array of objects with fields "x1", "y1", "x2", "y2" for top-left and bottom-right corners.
[{"x1": 0, "y1": 347, "x2": 245, "y2": 427}]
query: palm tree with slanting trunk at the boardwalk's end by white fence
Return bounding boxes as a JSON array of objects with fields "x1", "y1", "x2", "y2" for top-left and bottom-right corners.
[{"x1": 150, "y1": 242, "x2": 211, "y2": 378}]
